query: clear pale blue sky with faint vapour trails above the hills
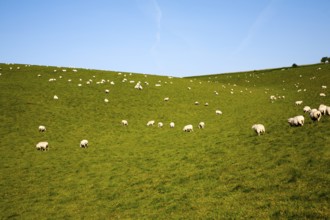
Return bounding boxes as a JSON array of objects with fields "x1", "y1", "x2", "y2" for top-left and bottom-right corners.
[{"x1": 0, "y1": 0, "x2": 330, "y2": 77}]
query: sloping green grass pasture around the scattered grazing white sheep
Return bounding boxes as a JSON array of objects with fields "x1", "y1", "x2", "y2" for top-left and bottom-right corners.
[{"x1": 0, "y1": 64, "x2": 330, "y2": 219}]
